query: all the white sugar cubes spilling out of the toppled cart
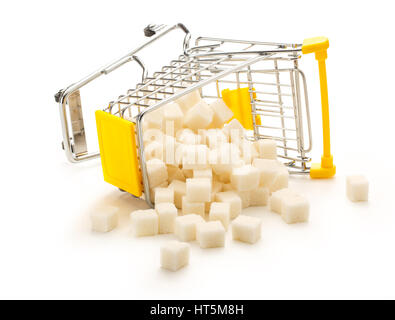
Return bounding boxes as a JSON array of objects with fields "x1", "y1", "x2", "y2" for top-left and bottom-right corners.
[{"x1": 92, "y1": 91, "x2": 370, "y2": 271}]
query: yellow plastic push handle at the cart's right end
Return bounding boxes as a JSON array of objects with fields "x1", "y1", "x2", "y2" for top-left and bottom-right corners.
[{"x1": 302, "y1": 37, "x2": 336, "y2": 178}]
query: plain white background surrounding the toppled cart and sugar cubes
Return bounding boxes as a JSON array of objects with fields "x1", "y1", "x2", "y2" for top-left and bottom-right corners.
[{"x1": 0, "y1": 0, "x2": 395, "y2": 299}]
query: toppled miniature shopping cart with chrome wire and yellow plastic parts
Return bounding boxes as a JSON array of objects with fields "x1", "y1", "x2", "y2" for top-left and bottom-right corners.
[{"x1": 55, "y1": 24, "x2": 336, "y2": 206}]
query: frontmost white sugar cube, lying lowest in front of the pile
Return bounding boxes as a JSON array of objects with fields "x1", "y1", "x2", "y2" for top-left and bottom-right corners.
[{"x1": 160, "y1": 241, "x2": 190, "y2": 271}]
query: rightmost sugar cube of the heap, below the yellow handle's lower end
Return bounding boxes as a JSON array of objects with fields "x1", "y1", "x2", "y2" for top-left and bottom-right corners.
[{"x1": 281, "y1": 195, "x2": 310, "y2": 223}]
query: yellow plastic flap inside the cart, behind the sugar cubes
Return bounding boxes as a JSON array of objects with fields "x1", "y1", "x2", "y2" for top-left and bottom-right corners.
[{"x1": 221, "y1": 88, "x2": 261, "y2": 130}]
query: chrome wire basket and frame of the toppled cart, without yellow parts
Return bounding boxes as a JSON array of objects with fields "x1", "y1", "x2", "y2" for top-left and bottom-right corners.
[{"x1": 55, "y1": 24, "x2": 312, "y2": 206}]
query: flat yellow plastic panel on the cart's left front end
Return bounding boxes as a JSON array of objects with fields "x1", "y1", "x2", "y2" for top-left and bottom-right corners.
[{"x1": 95, "y1": 110, "x2": 143, "y2": 197}]
